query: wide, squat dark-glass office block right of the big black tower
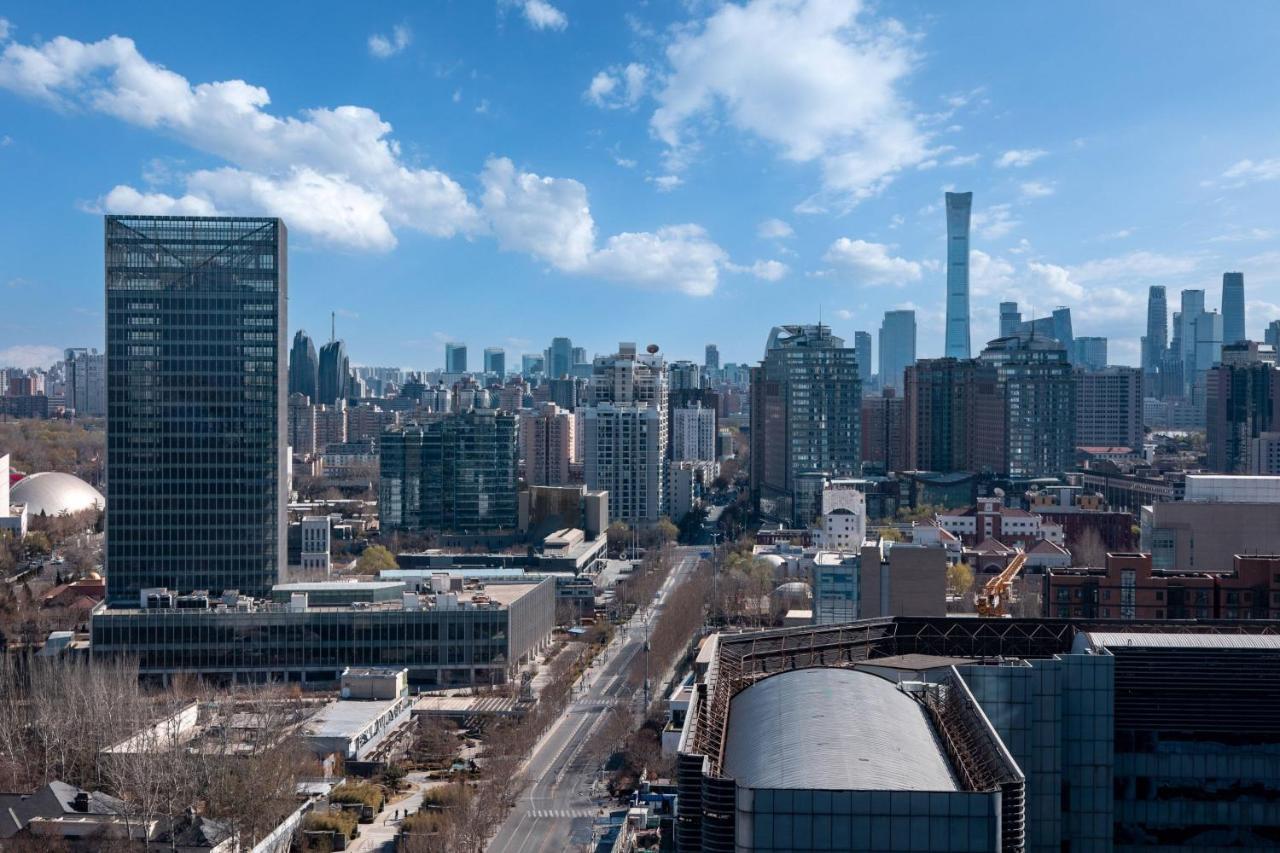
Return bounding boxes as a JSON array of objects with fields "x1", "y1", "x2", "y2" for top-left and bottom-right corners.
[{"x1": 378, "y1": 409, "x2": 520, "y2": 533}]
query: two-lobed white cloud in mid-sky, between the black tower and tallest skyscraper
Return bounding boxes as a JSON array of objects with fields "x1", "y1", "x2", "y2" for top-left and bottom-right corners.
[{"x1": 481, "y1": 158, "x2": 728, "y2": 296}]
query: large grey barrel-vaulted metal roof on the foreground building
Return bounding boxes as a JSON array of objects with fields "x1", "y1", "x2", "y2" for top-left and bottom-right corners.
[{"x1": 724, "y1": 669, "x2": 960, "y2": 792}]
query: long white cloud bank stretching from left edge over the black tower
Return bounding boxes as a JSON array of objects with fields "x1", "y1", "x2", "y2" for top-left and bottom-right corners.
[{"x1": 0, "y1": 30, "x2": 484, "y2": 248}]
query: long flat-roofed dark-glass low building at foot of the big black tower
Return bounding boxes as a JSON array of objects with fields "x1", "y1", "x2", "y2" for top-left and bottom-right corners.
[{"x1": 90, "y1": 578, "x2": 556, "y2": 686}]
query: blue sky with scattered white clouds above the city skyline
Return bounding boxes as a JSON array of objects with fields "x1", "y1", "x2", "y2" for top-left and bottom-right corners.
[{"x1": 0, "y1": 0, "x2": 1280, "y2": 368}]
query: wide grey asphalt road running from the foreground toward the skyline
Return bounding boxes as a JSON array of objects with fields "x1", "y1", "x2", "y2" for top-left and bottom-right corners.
[{"x1": 488, "y1": 547, "x2": 701, "y2": 853}]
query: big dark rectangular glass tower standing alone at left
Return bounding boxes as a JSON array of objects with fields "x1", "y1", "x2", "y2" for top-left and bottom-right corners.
[{"x1": 105, "y1": 216, "x2": 289, "y2": 606}]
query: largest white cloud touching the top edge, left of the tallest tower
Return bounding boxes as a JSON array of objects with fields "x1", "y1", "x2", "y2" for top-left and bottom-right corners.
[{"x1": 650, "y1": 0, "x2": 929, "y2": 202}]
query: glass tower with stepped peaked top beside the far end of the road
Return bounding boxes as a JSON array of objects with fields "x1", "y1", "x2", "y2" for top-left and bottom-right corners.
[{"x1": 750, "y1": 324, "x2": 863, "y2": 525}]
